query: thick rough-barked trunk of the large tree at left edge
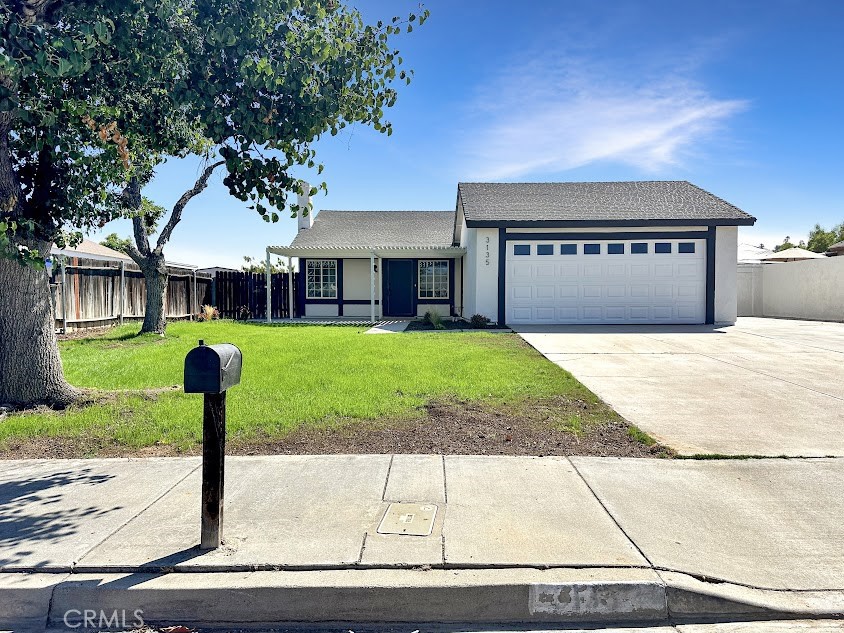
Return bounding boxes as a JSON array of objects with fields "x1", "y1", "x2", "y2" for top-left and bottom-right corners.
[{"x1": 0, "y1": 242, "x2": 80, "y2": 408}]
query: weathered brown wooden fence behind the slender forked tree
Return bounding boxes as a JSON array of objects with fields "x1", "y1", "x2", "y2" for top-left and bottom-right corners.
[{"x1": 51, "y1": 258, "x2": 212, "y2": 331}]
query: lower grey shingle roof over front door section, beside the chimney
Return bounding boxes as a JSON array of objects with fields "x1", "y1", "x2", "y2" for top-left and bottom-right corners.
[{"x1": 290, "y1": 210, "x2": 454, "y2": 248}]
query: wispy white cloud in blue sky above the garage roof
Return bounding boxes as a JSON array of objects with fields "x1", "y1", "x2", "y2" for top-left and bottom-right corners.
[{"x1": 464, "y1": 42, "x2": 748, "y2": 179}]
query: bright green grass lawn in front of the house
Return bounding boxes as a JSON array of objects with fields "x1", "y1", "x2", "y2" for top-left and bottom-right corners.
[{"x1": 0, "y1": 321, "x2": 597, "y2": 450}]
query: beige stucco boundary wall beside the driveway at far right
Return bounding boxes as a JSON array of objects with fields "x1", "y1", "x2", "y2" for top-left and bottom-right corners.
[{"x1": 760, "y1": 257, "x2": 844, "y2": 321}]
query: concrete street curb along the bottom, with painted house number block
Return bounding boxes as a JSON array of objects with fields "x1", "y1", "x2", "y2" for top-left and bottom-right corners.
[{"x1": 0, "y1": 568, "x2": 844, "y2": 631}]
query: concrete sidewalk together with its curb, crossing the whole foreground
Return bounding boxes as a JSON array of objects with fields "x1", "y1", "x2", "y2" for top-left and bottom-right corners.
[{"x1": 0, "y1": 455, "x2": 844, "y2": 629}]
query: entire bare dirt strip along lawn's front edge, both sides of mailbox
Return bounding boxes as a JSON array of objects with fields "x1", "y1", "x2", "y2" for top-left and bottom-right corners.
[{"x1": 0, "y1": 396, "x2": 673, "y2": 459}]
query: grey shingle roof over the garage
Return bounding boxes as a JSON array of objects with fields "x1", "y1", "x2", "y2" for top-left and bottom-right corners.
[{"x1": 457, "y1": 180, "x2": 756, "y2": 226}]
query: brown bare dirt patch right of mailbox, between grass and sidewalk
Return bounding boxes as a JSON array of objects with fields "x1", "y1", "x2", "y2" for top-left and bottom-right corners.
[{"x1": 231, "y1": 398, "x2": 672, "y2": 457}]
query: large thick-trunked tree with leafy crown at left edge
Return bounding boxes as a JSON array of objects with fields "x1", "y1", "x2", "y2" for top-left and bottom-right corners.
[{"x1": 0, "y1": 0, "x2": 199, "y2": 406}]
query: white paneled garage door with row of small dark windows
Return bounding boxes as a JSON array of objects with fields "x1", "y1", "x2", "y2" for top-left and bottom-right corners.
[{"x1": 505, "y1": 240, "x2": 706, "y2": 324}]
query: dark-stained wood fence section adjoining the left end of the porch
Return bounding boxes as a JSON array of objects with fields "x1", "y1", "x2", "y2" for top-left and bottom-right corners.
[{"x1": 211, "y1": 271, "x2": 299, "y2": 319}]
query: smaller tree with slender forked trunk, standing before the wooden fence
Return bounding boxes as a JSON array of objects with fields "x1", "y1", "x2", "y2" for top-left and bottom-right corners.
[{"x1": 120, "y1": 0, "x2": 427, "y2": 334}]
